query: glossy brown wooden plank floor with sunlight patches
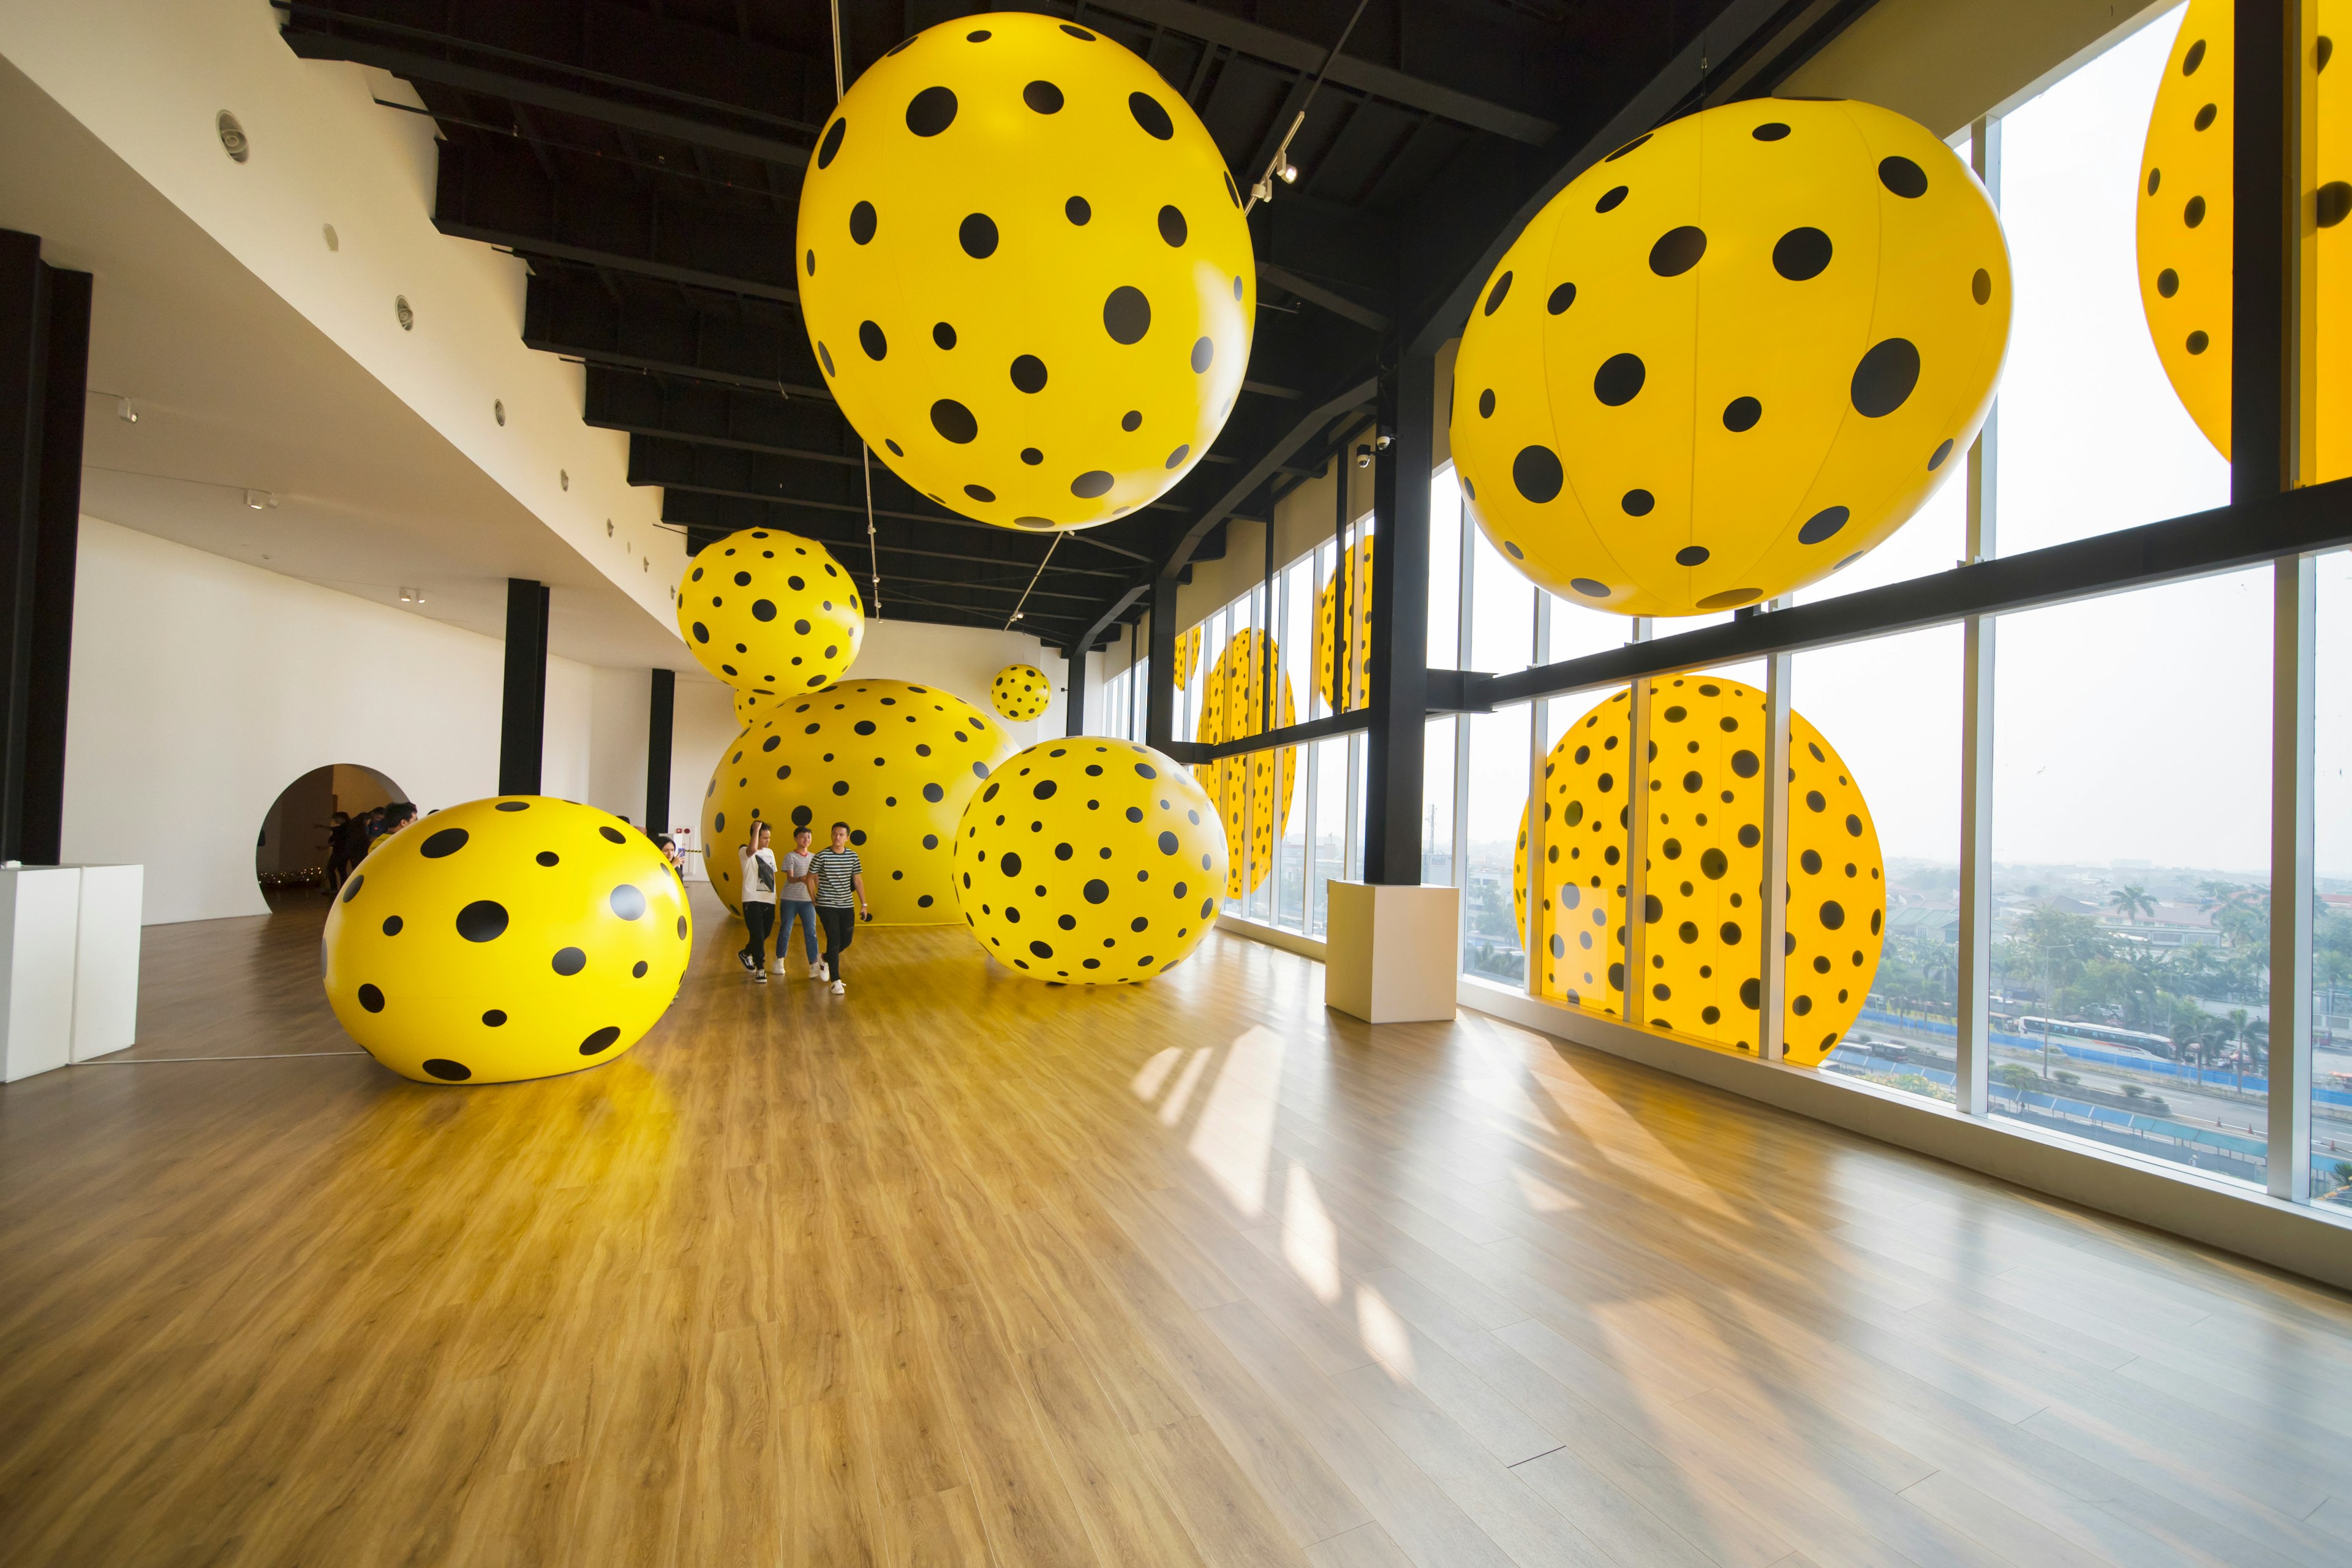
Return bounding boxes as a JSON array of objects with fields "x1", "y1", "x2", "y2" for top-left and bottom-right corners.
[{"x1": 0, "y1": 888, "x2": 2352, "y2": 1568}]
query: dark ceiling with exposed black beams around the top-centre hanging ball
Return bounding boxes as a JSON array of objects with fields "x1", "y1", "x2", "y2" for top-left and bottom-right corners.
[{"x1": 280, "y1": 0, "x2": 1860, "y2": 646}]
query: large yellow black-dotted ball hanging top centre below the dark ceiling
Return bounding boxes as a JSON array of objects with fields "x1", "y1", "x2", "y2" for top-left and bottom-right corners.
[{"x1": 800, "y1": 12, "x2": 1256, "y2": 529}]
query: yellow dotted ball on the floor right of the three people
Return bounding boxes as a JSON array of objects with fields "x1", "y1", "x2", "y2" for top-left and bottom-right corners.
[{"x1": 955, "y1": 736, "x2": 1226, "y2": 985}]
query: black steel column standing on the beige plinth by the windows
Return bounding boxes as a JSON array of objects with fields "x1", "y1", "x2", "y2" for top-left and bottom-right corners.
[{"x1": 1341, "y1": 355, "x2": 1437, "y2": 886}]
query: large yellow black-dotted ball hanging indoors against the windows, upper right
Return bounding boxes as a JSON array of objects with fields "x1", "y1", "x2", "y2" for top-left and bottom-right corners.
[{"x1": 1451, "y1": 99, "x2": 2008, "y2": 616}]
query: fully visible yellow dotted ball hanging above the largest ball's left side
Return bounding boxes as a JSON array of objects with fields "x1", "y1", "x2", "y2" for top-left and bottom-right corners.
[{"x1": 677, "y1": 529, "x2": 865, "y2": 696}]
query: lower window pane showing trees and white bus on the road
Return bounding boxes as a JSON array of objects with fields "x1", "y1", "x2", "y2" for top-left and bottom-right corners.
[{"x1": 1992, "y1": 569, "x2": 2270, "y2": 1183}]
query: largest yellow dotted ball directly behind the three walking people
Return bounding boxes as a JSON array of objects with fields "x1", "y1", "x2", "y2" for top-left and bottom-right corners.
[{"x1": 703, "y1": 679, "x2": 1011, "y2": 926}]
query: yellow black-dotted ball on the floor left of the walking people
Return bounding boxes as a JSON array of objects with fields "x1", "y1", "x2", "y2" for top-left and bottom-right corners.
[{"x1": 325, "y1": 794, "x2": 694, "y2": 1084}]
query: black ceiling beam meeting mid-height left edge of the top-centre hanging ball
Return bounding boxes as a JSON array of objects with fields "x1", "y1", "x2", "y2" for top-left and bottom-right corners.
[{"x1": 433, "y1": 137, "x2": 800, "y2": 303}]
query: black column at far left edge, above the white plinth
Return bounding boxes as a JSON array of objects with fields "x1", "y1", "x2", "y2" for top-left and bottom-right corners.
[{"x1": 0, "y1": 230, "x2": 89, "y2": 863}]
